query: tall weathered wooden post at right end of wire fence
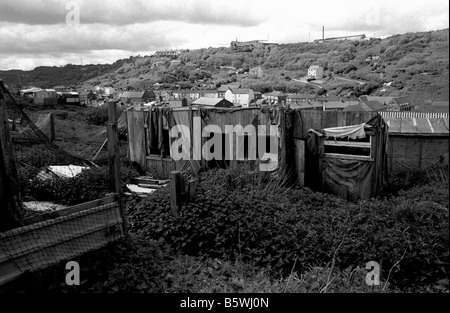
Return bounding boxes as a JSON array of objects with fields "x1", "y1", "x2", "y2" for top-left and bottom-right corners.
[{"x1": 107, "y1": 102, "x2": 128, "y2": 235}]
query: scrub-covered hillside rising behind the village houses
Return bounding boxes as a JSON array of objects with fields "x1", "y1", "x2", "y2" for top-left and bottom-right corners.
[{"x1": 0, "y1": 29, "x2": 449, "y2": 101}]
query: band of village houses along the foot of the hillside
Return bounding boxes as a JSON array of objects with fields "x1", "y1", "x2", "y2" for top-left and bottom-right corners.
[{"x1": 20, "y1": 84, "x2": 449, "y2": 113}]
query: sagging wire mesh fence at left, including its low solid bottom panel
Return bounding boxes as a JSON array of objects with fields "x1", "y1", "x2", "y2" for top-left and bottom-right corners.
[{"x1": 0, "y1": 81, "x2": 126, "y2": 286}]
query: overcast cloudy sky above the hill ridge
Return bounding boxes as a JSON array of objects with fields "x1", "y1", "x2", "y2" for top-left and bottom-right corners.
[{"x1": 0, "y1": 0, "x2": 449, "y2": 70}]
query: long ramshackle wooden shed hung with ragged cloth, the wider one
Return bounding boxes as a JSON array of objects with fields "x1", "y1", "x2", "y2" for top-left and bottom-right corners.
[{"x1": 127, "y1": 106, "x2": 286, "y2": 177}]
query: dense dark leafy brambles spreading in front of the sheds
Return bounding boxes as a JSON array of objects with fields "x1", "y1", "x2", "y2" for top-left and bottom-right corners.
[{"x1": 127, "y1": 165, "x2": 449, "y2": 288}]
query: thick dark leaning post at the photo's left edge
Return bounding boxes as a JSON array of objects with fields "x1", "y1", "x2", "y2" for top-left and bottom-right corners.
[{"x1": 0, "y1": 80, "x2": 23, "y2": 228}]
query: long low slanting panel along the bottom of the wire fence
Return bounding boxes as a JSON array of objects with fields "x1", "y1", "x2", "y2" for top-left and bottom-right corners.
[{"x1": 0, "y1": 202, "x2": 124, "y2": 285}]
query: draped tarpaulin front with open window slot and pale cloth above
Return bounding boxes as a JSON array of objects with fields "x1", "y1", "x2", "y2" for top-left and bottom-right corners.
[{"x1": 308, "y1": 115, "x2": 388, "y2": 201}]
